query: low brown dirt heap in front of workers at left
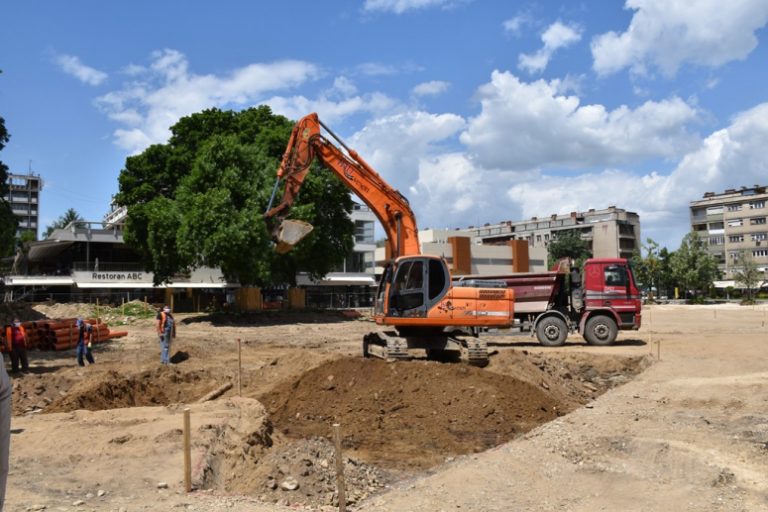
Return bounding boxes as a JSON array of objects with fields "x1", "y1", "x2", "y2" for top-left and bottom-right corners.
[{"x1": 45, "y1": 367, "x2": 220, "y2": 413}]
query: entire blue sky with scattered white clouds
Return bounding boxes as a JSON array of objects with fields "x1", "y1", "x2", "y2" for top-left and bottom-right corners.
[{"x1": 0, "y1": 0, "x2": 768, "y2": 250}]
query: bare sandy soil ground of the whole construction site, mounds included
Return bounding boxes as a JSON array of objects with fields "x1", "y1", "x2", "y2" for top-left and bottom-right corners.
[{"x1": 6, "y1": 305, "x2": 768, "y2": 511}]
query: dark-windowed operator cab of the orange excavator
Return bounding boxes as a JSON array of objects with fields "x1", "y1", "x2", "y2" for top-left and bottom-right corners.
[{"x1": 375, "y1": 256, "x2": 451, "y2": 318}]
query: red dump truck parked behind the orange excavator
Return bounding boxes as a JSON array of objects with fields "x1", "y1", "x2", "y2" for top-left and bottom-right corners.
[{"x1": 456, "y1": 258, "x2": 642, "y2": 347}]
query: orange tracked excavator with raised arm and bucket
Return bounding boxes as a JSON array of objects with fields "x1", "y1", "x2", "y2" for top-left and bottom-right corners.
[{"x1": 265, "y1": 113, "x2": 514, "y2": 365}]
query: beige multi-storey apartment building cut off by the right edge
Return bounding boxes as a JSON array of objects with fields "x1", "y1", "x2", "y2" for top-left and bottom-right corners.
[{"x1": 690, "y1": 185, "x2": 768, "y2": 279}]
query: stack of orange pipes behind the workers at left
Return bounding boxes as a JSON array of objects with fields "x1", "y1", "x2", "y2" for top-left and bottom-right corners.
[{"x1": 2, "y1": 318, "x2": 128, "y2": 350}]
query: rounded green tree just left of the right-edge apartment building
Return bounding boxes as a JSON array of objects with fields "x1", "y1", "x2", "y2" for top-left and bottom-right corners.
[{"x1": 670, "y1": 231, "x2": 720, "y2": 299}]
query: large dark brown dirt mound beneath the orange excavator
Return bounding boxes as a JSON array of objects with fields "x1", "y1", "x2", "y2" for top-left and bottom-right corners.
[{"x1": 260, "y1": 358, "x2": 571, "y2": 469}]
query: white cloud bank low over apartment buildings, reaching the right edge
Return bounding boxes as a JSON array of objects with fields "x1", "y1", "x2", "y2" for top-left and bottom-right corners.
[{"x1": 506, "y1": 103, "x2": 768, "y2": 249}]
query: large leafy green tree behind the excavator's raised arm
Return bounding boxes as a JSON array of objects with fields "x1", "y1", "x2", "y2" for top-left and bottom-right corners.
[{"x1": 115, "y1": 106, "x2": 354, "y2": 285}]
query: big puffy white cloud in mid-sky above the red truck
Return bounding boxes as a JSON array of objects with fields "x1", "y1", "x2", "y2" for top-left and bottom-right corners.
[{"x1": 461, "y1": 71, "x2": 698, "y2": 170}]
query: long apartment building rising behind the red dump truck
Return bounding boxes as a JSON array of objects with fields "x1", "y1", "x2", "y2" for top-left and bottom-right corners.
[{"x1": 458, "y1": 206, "x2": 641, "y2": 260}]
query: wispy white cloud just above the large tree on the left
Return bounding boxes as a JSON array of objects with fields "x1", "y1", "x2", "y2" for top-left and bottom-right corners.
[{"x1": 96, "y1": 49, "x2": 321, "y2": 152}]
